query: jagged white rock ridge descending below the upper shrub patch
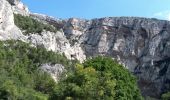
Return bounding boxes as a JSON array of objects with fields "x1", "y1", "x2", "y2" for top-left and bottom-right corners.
[{"x1": 25, "y1": 31, "x2": 86, "y2": 62}]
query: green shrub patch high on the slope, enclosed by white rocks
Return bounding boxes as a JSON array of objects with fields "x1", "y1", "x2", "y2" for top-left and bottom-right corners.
[{"x1": 14, "y1": 14, "x2": 57, "y2": 34}]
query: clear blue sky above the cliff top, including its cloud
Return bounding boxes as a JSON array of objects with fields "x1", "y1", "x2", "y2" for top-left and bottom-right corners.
[{"x1": 22, "y1": 0, "x2": 170, "y2": 20}]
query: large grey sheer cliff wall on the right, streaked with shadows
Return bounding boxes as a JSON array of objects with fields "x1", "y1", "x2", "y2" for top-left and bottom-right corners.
[{"x1": 63, "y1": 17, "x2": 170, "y2": 97}]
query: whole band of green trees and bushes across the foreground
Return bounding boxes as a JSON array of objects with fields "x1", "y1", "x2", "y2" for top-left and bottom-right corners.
[{"x1": 0, "y1": 40, "x2": 143, "y2": 100}]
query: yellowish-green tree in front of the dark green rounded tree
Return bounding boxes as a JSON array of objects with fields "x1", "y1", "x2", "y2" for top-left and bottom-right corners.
[{"x1": 51, "y1": 64, "x2": 116, "y2": 100}]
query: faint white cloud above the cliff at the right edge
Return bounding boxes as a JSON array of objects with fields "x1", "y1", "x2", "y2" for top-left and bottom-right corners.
[{"x1": 153, "y1": 10, "x2": 170, "y2": 21}]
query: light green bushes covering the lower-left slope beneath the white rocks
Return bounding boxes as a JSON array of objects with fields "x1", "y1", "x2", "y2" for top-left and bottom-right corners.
[{"x1": 0, "y1": 41, "x2": 68, "y2": 100}]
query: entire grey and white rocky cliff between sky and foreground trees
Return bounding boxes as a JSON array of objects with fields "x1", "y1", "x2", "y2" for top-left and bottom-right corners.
[{"x1": 0, "y1": 0, "x2": 170, "y2": 97}]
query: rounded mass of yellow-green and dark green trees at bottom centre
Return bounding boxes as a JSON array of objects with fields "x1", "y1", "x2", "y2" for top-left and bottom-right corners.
[{"x1": 52, "y1": 57, "x2": 143, "y2": 100}]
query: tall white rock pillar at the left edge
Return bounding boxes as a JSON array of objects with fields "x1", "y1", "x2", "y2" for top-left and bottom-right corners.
[{"x1": 0, "y1": 0, "x2": 24, "y2": 40}]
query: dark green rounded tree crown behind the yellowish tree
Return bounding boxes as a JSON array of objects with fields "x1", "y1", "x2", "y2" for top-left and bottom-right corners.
[{"x1": 83, "y1": 56, "x2": 143, "y2": 100}]
